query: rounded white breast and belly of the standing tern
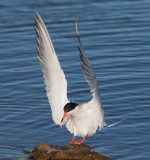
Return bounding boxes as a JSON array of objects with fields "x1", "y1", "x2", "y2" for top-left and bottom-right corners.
[{"x1": 66, "y1": 103, "x2": 100, "y2": 138}]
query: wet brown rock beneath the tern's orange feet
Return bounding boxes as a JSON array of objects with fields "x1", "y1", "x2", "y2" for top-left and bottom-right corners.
[{"x1": 30, "y1": 143, "x2": 111, "y2": 160}]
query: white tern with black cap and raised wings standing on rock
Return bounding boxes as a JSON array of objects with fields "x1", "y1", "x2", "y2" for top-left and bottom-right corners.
[{"x1": 35, "y1": 13, "x2": 107, "y2": 145}]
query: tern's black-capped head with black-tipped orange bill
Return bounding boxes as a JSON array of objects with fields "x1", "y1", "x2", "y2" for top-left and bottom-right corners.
[{"x1": 61, "y1": 102, "x2": 78, "y2": 123}]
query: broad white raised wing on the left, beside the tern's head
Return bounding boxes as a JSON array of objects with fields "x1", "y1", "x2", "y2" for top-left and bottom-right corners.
[{"x1": 35, "y1": 13, "x2": 68, "y2": 125}]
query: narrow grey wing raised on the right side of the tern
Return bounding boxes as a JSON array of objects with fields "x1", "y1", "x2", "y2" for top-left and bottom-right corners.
[{"x1": 76, "y1": 21, "x2": 106, "y2": 128}]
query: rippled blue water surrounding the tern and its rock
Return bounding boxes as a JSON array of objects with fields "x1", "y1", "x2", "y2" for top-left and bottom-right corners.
[{"x1": 0, "y1": 0, "x2": 150, "y2": 160}]
